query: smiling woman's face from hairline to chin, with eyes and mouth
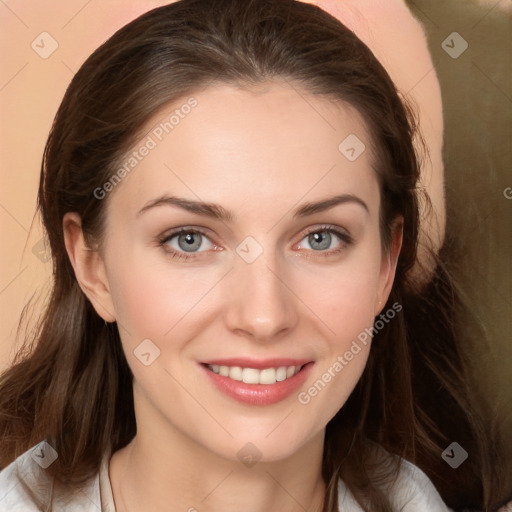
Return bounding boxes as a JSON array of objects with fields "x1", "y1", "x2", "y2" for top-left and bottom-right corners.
[{"x1": 76, "y1": 82, "x2": 400, "y2": 460}]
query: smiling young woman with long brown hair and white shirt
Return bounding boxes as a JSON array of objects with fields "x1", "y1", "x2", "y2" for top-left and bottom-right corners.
[{"x1": 0, "y1": 0, "x2": 506, "y2": 512}]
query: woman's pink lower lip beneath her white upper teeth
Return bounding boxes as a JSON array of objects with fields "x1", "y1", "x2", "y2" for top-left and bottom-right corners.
[{"x1": 200, "y1": 362, "x2": 314, "y2": 405}]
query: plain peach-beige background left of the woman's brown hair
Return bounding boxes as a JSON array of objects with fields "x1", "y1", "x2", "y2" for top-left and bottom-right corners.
[{"x1": 0, "y1": 0, "x2": 172, "y2": 368}]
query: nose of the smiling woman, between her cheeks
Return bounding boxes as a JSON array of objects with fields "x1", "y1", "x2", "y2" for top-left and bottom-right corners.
[{"x1": 225, "y1": 250, "x2": 299, "y2": 342}]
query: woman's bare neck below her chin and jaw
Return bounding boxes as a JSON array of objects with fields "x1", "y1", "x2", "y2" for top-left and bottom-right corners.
[{"x1": 109, "y1": 424, "x2": 325, "y2": 512}]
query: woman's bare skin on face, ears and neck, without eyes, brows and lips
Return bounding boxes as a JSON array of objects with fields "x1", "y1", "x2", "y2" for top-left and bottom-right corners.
[{"x1": 63, "y1": 81, "x2": 401, "y2": 512}]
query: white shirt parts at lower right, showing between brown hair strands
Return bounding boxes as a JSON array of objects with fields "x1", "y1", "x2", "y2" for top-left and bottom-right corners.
[{"x1": 338, "y1": 454, "x2": 451, "y2": 512}]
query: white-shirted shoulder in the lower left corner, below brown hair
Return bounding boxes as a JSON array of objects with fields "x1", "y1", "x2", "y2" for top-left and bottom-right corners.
[{"x1": 0, "y1": 441, "x2": 101, "y2": 512}]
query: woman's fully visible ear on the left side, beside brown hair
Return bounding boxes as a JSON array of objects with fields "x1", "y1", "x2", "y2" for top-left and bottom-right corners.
[{"x1": 62, "y1": 212, "x2": 116, "y2": 322}]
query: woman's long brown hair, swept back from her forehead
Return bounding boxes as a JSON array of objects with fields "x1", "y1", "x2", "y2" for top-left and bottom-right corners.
[{"x1": 0, "y1": 0, "x2": 506, "y2": 512}]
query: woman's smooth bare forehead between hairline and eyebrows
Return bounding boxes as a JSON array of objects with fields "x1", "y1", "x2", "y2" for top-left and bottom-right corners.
[{"x1": 106, "y1": 82, "x2": 377, "y2": 221}]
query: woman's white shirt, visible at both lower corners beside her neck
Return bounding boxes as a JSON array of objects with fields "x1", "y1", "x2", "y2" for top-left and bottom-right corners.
[{"x1": 0, "y1": 441, "x2": 451, "y2": 512}]
